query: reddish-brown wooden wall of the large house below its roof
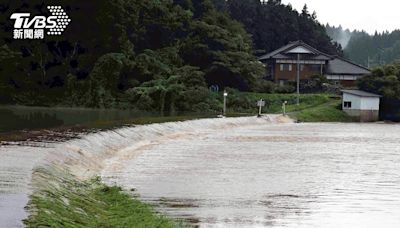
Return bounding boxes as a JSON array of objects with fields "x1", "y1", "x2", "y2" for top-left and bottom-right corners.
[{"x1": 274, "y1": 63, "x2": 321, "y2": 82}]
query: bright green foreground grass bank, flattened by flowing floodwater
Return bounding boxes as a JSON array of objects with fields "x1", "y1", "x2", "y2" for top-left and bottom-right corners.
[{"x1": 24, "y1": 168, "x2": 184, "y2": 227}]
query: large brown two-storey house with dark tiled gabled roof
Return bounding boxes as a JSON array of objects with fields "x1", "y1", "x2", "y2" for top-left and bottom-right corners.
[{"x1": 259, "y1": 41, "x2": 371, "y2": 87}]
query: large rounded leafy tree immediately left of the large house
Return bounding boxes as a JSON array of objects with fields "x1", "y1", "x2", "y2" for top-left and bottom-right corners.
[{"x1": 182, "y1": 2, "x2": 264, "y2": 90}]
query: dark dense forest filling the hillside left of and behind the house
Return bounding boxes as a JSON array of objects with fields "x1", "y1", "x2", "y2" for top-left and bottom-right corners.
[{"x1": 0, "y1": 0, "x2": 341, "y2": 114}]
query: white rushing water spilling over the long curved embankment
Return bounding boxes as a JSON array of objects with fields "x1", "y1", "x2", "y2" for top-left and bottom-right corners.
[{"x1": 0, "y1": 116, "x2": 279, "y2": 227}]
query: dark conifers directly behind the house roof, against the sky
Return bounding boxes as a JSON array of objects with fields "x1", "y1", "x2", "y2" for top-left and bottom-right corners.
[{"x1": 223, "y1": 0, "x2": 342, "y2": 55}]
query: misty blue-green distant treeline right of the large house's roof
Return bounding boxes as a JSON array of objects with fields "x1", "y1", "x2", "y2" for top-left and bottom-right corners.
[{"x1": 326, "y1": 24, "x2": 400, "y2": 67}]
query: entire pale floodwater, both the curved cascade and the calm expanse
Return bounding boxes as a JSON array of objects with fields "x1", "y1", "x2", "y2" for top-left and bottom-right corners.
[{"x1": 0, "y1": 116, "x2": 400, "y2": 227}]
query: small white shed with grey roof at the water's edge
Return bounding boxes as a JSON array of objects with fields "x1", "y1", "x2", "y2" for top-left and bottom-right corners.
[{"x1": 342, "y1": 90, "x2": 382, "y2": 122}]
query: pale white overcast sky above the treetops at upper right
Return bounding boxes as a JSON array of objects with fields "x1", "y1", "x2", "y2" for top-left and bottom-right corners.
[{"x1": 282, "y1": 0, "x2": 400, "y2": 34}]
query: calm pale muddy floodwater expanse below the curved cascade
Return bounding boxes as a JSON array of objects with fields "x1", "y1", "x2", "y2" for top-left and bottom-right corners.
[{"x1": 103, "y1": 123, "x2": 400, "y2": 228}]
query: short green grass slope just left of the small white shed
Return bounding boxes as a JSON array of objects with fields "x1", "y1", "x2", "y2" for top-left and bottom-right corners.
[{"x1": 290, "y1": 100, "x2": 355, "y2": 122}]
